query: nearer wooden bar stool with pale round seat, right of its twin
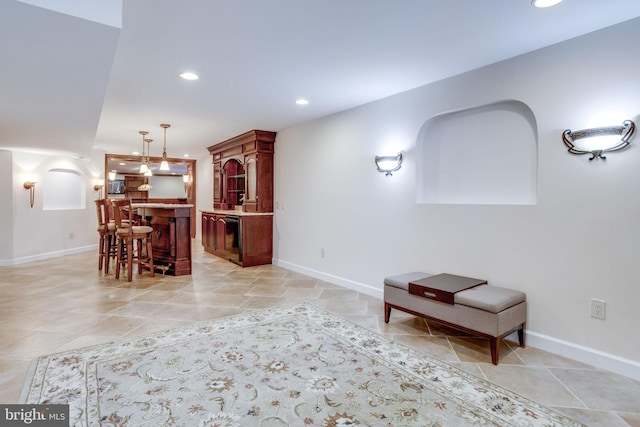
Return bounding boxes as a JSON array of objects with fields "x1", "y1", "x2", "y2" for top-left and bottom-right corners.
[{"x1": 112, "y1": 199, "x2": 154, "y2": 282}]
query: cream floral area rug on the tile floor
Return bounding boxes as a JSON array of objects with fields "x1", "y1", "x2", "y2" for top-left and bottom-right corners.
[{"x1": 21, "y1": 304, "x2": 581, "y2": 427}]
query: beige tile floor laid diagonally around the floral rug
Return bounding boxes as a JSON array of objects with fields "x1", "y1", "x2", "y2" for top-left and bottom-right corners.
[{"x1": 0, "y1": 241, "x2": 640, "y2": 427}]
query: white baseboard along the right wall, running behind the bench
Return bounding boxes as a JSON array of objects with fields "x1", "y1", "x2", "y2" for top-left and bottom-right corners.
[{"x1": 273, "y1": 259, "x2": 640, "y2": 380}]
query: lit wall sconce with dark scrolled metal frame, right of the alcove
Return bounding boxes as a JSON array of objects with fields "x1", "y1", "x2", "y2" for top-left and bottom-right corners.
[{"x1": 562, "y1": 120, "x2": 636, "y2": 160}]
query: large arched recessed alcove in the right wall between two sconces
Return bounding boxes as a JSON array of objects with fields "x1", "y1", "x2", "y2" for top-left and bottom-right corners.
[{"x1": 416, "y1": 100, "x2": 538, "y2": 205}]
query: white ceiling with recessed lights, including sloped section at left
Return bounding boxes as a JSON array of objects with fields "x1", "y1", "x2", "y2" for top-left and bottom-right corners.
[{"x1": 0, "y1": 0, "x2": 640, "y2": 157}]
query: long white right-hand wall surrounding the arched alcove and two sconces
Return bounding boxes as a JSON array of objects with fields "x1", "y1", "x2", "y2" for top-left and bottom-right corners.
[{"x1": 274, "y1": 19, "x2": 640, "y2": 378}]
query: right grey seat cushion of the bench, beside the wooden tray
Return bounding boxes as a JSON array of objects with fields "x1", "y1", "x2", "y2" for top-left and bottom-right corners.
[{"x1": 453, "y1": 285, "x2": 526, "y2": 313}]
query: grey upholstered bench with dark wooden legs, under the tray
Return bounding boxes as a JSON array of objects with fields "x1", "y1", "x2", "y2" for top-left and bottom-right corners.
[{"x1": 384, "y1": 272, "x2": 527, "y2": 365}]
